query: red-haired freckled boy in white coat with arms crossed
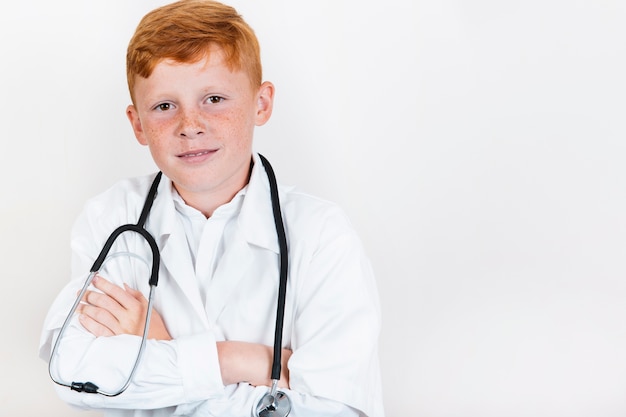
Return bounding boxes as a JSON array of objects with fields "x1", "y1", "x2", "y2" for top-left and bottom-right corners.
[{"x1": 40, "y1": 0, "x2": 383, "y2": 417}]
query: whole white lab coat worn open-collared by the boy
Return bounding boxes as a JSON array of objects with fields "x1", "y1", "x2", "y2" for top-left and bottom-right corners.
[{"x1": 40, "y1": 155, "x2": 384, "y2": 417}]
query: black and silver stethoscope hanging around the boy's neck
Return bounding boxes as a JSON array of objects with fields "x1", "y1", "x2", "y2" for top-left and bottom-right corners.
[{"x1": 48, "y1": 154, "x2": 291, "y2": 417}]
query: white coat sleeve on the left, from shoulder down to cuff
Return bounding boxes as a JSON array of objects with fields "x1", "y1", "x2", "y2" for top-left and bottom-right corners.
[{"x1": 39, "y1": 187, "x2": 224, "y2": 409}]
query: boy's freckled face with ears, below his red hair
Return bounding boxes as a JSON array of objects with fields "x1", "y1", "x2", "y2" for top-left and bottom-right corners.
[{"x1": 127, "y1": 47, "x2": 274, "y2": 210}]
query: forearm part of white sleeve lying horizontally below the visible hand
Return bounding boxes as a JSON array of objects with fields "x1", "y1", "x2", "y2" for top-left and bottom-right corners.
[{"x1": 44, "y1": 319, "x2": 224, "y2": 409}]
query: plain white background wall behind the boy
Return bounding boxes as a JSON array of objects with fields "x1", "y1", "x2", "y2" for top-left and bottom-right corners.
[{"x1": 0, "y1": 0, "x2": 626, "y2": 417}]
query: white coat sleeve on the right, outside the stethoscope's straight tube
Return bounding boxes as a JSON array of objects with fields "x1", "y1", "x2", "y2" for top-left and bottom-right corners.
[{"x1": 280, "y1": 205, "x2": 384, "y2": 417}]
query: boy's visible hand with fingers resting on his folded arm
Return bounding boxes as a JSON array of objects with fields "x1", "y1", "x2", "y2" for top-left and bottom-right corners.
[{"x1": 78, "y1": 275, "x2": 172, "y2": 340}]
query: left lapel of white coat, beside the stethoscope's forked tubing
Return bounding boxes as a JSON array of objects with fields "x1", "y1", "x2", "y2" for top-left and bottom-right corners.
[{"x1": 148, "y1": 176, "x2": 208, "y2": 324}]
